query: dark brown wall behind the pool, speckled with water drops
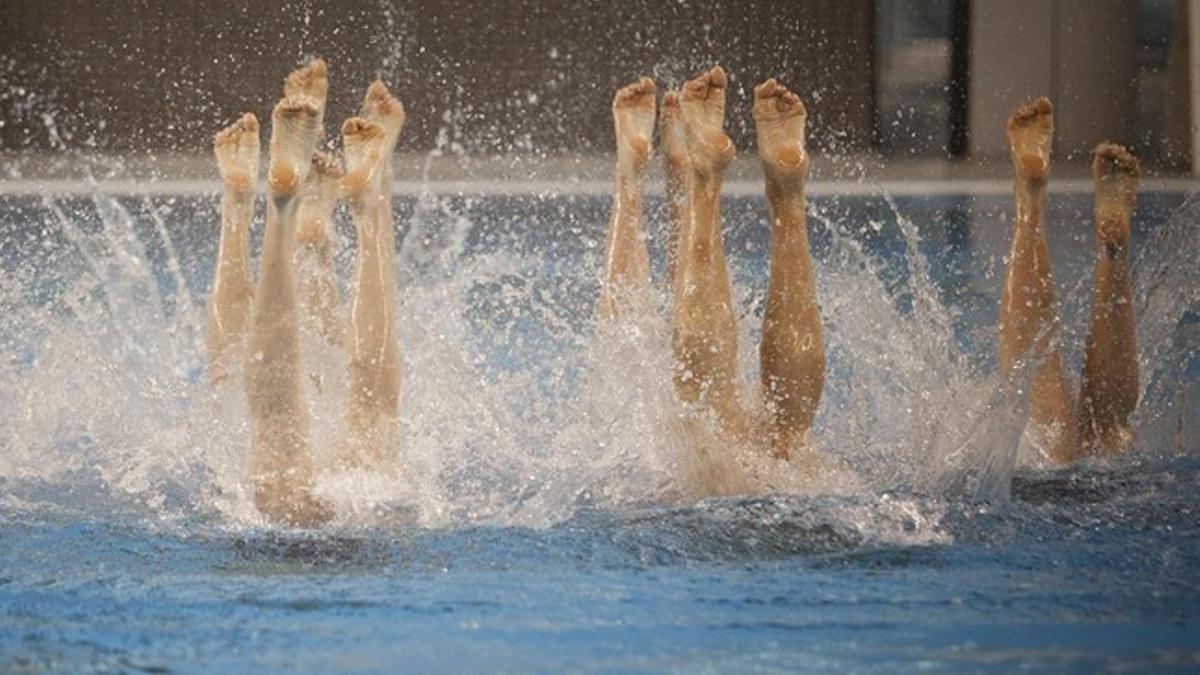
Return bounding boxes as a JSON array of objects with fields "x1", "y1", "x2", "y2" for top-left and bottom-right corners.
[{"x1": 0, "y1": 0, "x2": 874, "y2": 153}]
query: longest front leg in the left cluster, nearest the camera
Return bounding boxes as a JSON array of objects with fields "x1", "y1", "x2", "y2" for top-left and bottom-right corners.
[{"x1": 246, "y1": 62, "x2": 332, "y2": 526}]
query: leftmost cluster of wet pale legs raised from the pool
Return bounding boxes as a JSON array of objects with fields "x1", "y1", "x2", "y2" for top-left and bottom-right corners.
[{"x1": 209, "y1": 60, "x2": 404, "y2": 525}]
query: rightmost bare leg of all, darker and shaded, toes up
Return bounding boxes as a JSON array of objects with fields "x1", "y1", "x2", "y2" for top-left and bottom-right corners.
[{"x1": 1079, "y1": 143, "x2": 1140, "y2": 453}]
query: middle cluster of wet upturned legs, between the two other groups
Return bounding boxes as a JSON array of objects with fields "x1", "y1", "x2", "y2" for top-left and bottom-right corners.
[{"x1": 599, "y1": 67, "x2": 824, "y2": 466}]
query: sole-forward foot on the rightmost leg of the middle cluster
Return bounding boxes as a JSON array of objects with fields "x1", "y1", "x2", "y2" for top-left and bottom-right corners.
[{"x1": 754, "y1": 79, "x2": 809, "y2": 187}]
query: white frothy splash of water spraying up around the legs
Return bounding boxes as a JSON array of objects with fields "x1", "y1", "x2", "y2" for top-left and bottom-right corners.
[{"x1": 0, "y1": 180, "x2": 1200, "y2": 535}]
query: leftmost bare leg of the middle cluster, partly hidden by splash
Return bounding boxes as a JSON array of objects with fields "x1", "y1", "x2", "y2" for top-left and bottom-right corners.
[{"x1": 599, "y1": 77, "x2": 654, "y2": 319}]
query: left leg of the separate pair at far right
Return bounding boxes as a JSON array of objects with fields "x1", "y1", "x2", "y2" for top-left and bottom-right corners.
[{"x1": 1000, "y1": 98, "x2": 1076, "y2": 461}]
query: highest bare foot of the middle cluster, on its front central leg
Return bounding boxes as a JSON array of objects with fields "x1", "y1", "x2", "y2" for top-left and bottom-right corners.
[{"x1": 680, "y1": 66, "x2": 734, "y2": 175}]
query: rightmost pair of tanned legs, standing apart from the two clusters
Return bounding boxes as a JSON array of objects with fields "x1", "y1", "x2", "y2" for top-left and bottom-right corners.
[{"x1": 1000, "y1": 98, "x2": 1139, "y2": 462}]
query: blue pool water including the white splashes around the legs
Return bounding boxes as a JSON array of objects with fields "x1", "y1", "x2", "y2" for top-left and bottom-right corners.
[{"x1": 0, "y1": 184, "x2": 1200, "y2": 673}]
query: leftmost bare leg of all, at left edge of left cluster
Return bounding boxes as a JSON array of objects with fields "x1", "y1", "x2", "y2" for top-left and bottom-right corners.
[{"x1": 208, "y1": 113, "x2": 259, "y2": 383}]
